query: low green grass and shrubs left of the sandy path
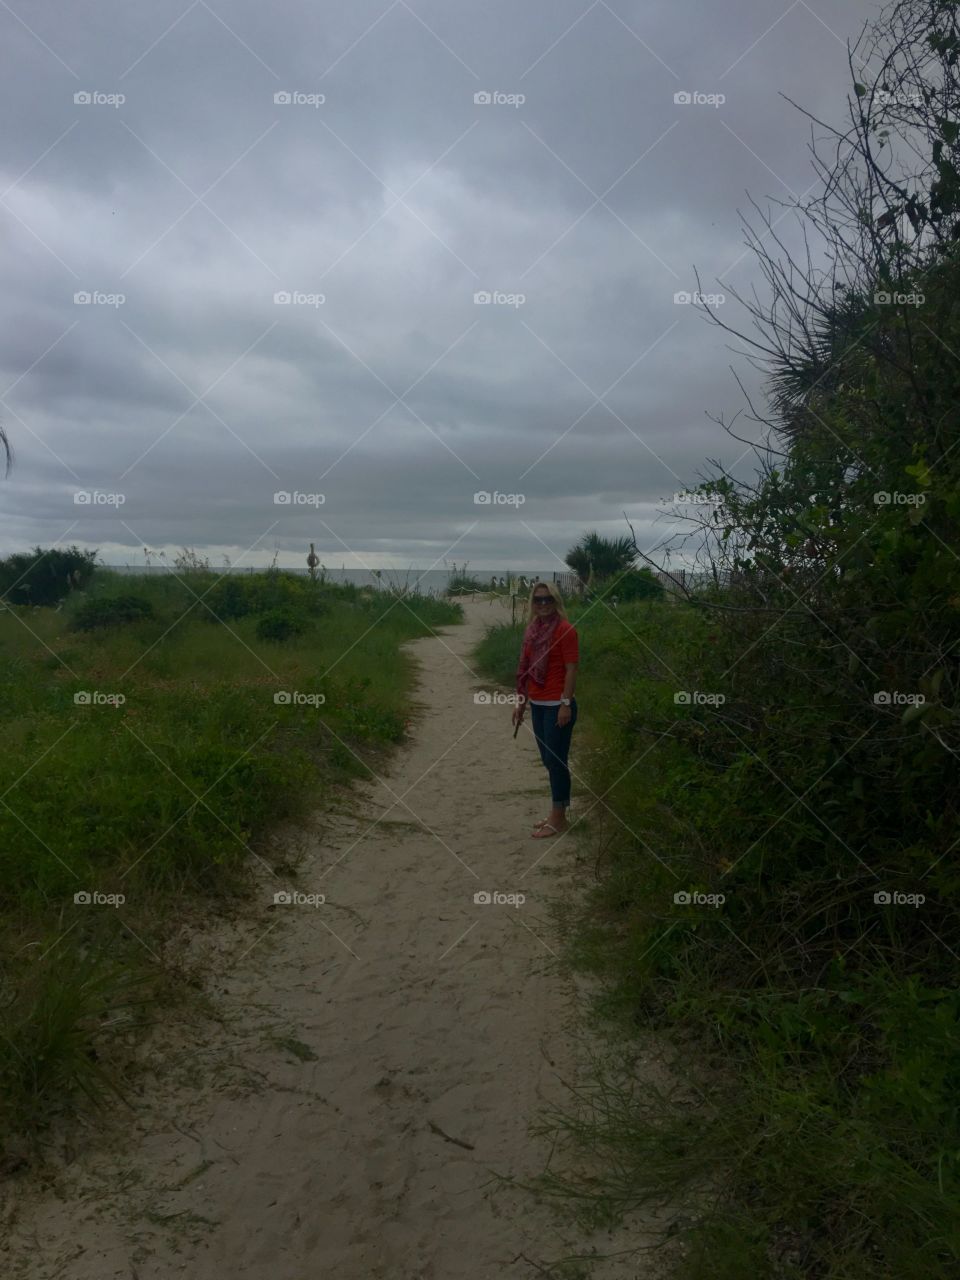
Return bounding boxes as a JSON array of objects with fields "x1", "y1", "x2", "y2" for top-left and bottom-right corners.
[{"x1": 0, "y1": 560, "x2": 461, "y2": 1162}]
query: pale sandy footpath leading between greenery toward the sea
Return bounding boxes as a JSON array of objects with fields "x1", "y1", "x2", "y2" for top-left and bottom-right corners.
[{"x1": 4, "y1": 600, "x2": 655, "y2": 1280}]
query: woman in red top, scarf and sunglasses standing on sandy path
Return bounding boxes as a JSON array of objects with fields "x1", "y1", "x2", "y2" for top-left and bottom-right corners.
[{"x1": 513, "y1": 582, "x2": 580, "y2": 840}]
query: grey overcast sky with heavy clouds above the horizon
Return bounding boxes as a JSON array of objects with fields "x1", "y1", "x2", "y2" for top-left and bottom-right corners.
[{"x1": 0, "y1": 0, "x2": 877, "y2": 570}]
